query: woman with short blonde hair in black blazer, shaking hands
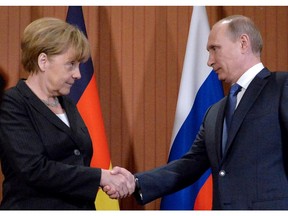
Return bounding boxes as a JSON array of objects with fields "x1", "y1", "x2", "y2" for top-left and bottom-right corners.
[{"x1": 0, "y1": 18, "x2": 133, "y2": 209}]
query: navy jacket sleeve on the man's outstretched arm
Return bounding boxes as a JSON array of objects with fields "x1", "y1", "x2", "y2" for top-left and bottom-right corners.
[{"x1": 135, "y1": 120, "x2": 209, "y2": 204}]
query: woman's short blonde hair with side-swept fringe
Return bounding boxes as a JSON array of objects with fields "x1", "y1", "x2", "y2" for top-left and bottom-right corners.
[{"x1": 21, "y1": 17, "x2": 90, "y2": 73}]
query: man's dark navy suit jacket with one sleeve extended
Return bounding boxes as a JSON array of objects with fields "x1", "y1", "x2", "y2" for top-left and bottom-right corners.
[{"x1": 136, "y1": 68, "x2": 288, "y2": 210}]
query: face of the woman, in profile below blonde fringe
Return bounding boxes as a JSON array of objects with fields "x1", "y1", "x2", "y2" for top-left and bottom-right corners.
[{"x1": 40, "y1": 48, "x2": 81, "y2": 96}]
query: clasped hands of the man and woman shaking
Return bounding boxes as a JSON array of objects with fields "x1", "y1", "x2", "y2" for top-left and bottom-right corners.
[{"x1": 100, "y1": 166, "x2": 135, "y2": 199}]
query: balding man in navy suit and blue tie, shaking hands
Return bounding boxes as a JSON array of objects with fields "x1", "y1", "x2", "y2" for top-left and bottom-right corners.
[{"x1": 105, "y1": 16, "x2": 288, "y2": 209}]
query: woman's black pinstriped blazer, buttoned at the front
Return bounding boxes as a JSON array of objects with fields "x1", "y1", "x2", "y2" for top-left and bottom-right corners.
[{"x1": 0, "y1": 80, "x2": 101, "y2": 209}]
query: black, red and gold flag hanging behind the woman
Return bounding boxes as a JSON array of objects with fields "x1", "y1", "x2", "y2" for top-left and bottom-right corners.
[{"x1": 66, "y1": 6, "x2": 119, "y2": 210}]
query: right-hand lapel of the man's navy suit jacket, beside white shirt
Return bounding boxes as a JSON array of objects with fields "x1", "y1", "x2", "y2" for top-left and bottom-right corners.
[{"x1": 223, "y1": 68, "x2": 271, "y2": 159}]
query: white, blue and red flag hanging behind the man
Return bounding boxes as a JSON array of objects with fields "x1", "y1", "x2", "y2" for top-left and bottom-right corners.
[{"x1": 160, "y1": 6, "x2": 224, "y2": 210}]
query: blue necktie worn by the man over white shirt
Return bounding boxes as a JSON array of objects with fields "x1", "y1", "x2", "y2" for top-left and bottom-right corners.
[{"x1": 222, "y1": 83, "x2": 242, "y2": 154}]
